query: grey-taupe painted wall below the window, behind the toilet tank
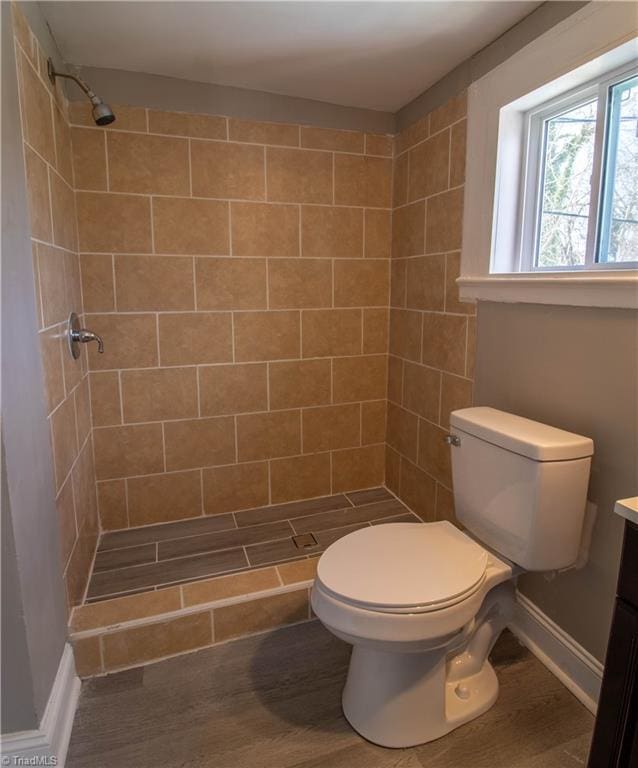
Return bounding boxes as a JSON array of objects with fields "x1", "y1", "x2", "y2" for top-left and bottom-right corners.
[{"x1": 475, "y1": 302, "x2": 638, "y2": 661}]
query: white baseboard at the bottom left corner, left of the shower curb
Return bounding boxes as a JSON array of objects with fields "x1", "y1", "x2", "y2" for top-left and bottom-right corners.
[{"x1": 0, "y1": 643, "x2": 80, "y2": 768}]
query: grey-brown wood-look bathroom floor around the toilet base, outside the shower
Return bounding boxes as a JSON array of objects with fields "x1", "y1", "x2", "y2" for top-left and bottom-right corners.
[{"x1": 67, "y1": 621, "x2": 593, "y2": 768}]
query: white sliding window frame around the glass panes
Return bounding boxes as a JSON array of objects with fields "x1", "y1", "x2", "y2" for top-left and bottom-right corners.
[{"x1": 515, "y1": 62, "x2": 638, "y2": 274}]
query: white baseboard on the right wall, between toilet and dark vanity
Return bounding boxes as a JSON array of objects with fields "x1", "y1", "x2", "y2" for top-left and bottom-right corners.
[{"x1": 509, "y1": 590, "x2": 603, "y2": 715}]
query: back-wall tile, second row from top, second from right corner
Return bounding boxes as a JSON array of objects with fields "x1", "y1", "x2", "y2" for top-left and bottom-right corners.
[{"x1": 266, "y1": 147, "x2": 332, "y2": 203}]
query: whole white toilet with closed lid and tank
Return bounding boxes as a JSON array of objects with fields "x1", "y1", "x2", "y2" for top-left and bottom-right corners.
[{"x1": 311, "y1": 407, "x2": 594, "y2": 747}]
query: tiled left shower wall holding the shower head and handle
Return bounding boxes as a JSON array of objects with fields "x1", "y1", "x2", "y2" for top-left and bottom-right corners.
[{"x1": 13, "y1": 1, "x2": 98, "y2": 607}]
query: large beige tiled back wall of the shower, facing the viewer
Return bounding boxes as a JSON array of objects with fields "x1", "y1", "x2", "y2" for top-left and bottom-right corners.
[{"x1": 71, "y1": 103, "x2": 392, "y2": 528}]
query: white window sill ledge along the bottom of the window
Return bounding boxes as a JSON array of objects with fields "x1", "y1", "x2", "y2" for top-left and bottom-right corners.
[{"x1": 457, "y1": 269, "x2": 638, "y2": 309}]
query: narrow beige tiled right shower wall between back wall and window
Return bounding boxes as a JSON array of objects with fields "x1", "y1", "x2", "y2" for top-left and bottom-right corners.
[{"x1": 386, "y1": 93, "x2": 474, "y2": 520}]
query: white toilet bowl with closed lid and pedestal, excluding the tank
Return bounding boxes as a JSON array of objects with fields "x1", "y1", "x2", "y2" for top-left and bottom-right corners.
[{"x1": 311, "y1": 522, "x2": 514, "y2": 747}]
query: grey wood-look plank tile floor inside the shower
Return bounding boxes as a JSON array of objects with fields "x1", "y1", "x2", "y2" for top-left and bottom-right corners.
[{"x1": 86, "y1": 488, "x2": 421, "y2": 603}]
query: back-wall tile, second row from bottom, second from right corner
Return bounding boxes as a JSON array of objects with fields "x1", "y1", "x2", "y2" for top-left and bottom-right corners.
[{"x1": 302, "y1": 403, "x2": 361, "y2": 453}]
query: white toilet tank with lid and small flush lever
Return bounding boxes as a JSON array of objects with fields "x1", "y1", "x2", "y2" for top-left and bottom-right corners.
[{"x1": 450, "y1": 408, "x2": 594, "y2": 571}]
